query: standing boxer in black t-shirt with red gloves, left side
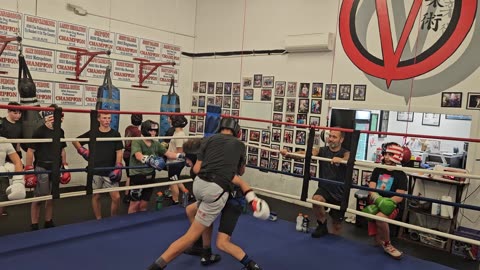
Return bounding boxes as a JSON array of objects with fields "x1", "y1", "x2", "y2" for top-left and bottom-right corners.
[{"x1": 25, "y1": 104, "x2": 71, "y2": 231}]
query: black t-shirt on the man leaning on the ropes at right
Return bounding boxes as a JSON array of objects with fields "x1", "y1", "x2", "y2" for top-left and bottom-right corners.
[{"x1": 318, "y1": 146, "x2": 348, "y2": 200}]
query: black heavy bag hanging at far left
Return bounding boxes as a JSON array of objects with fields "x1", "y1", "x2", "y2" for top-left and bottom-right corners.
[{"x1": 18, "y1": 54, "x2": 43, "y2": 151}]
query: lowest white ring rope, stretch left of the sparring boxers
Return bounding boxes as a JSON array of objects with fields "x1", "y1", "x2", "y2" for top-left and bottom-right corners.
[{"x1": 0, "y1": 178, "x2": 193, "y2": 207}]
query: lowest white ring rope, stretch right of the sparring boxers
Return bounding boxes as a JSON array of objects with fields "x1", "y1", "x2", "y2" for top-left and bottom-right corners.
[{"x1": 253, "y1": 187, "x2": 480, "y2": 246}]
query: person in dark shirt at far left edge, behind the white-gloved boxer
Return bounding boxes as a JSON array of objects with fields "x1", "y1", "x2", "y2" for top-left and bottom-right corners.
[{"x1": 0, "y1": 102, "x2": 23, "y2": 216}]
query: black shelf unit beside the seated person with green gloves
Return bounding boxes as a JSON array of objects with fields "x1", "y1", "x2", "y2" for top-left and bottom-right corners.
[{"x1": 399, "y1": 173, "x2": 468, "y2": 251}]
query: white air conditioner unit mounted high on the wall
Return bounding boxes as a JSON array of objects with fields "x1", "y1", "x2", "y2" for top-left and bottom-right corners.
[{"x1": 285, "y1": 33, "x2": 335, "y2": 53}]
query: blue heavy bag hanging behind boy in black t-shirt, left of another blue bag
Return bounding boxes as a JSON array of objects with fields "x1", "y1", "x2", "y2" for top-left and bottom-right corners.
[{"x1": 95, "y1": 66, "x2": 120, "y2": 131}]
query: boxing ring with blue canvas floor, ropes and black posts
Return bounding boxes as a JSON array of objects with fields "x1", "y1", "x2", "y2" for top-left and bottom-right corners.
[{"x1": 0, "y1": 105, "x2": 480, "y2": 270}]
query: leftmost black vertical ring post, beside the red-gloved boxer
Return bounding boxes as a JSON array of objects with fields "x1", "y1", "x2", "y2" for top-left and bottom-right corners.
[{"x1": 49, "y1": 107, "x2": 62, "y2": 199}]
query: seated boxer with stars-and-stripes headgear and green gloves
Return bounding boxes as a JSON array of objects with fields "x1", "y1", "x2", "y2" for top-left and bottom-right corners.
[{"x1": 363, "y1": 142, "x2": 407, "y2": 259}]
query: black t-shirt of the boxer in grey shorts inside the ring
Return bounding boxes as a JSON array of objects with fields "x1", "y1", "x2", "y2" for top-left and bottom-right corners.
[{"x1": 198, "y1": 133, "x2": 246, "y2": 192}]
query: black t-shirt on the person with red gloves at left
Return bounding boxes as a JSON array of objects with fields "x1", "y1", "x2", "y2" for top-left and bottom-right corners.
[{"x1": 29, "y1": 125, "x2": 67, "y2": 165}]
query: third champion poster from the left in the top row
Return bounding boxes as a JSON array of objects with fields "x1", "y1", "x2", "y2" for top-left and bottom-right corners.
[{"x1": 57, "y1": 22, "x2": 87, "y2": 48}]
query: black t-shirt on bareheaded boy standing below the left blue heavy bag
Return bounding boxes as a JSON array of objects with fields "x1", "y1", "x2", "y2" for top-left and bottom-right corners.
[{"x1": 78, "y1": 129, "x2": 123, "y2": 176}]
